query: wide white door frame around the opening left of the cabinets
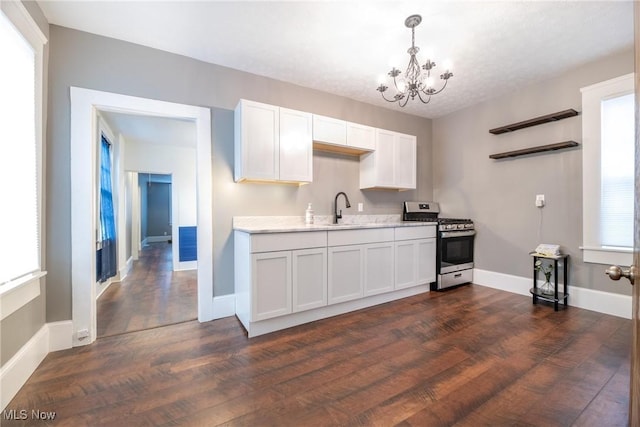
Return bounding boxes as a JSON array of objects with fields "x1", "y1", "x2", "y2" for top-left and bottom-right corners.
[{"x1": 70, "y1": 86, "x2": 214, "y2": 347}]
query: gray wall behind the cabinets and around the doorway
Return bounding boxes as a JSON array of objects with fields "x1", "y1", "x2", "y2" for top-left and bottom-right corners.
[{"x1": 47, "y1": 25, "x2": 433, "y2": 321}]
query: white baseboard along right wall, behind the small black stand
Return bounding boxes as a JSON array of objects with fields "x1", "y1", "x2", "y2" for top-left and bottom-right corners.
[{"x1": 473, "y1": 268, "x2": 632, "y2": 319}]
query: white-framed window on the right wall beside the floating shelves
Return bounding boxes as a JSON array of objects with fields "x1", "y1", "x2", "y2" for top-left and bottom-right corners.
[{"x1": 582, "y1": 74, "x2": 635, "y2": 265}]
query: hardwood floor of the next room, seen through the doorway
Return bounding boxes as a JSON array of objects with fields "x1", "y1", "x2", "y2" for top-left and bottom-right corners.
[{"x1": 96, "y1": 242, "x2": 198, "y2": 337}]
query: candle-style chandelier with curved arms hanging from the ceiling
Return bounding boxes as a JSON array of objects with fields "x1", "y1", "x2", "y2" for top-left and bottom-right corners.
[{"x1": 376, "y1": 15, "x2": 453, "y2": 107}]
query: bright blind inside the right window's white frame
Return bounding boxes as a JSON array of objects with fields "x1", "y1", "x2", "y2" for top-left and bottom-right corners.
[{"x1": 600, "y1": 94, "x2": 635, "y2": 247}]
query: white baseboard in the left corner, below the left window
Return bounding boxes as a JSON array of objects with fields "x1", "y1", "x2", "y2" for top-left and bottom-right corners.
[{"x1": 0, "y1": 320, "x2": 73, "y2": 410}]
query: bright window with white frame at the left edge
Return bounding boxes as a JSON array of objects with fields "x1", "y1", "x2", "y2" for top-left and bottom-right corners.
[{"x1": 0, "y1": 1, "x2": 46, "y2": 317}]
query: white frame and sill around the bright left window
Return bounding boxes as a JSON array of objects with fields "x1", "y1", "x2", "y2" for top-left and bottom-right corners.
[{"x1": 0, "y1": 0, "x2": 48, "y2": 320}]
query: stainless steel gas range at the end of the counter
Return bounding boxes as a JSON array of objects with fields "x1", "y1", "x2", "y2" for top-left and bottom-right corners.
[{"x1": 402, "y1": 202, "x2": 476, "y2": 290}]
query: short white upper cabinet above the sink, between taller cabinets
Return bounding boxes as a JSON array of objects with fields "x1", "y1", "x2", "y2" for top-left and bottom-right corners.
[{"x1": 313, "y1": 114, "x2": 376, "y2": 155}]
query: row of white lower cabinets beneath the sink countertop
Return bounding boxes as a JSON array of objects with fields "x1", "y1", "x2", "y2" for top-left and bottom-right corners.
[{"x1": 234, "y1": 226, "x2": 436, "y2": 337}]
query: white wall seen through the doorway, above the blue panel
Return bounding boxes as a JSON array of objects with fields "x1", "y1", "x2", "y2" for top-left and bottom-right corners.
[{"x1": 124, "y1": 140, "x2": 198, "y2": 270}]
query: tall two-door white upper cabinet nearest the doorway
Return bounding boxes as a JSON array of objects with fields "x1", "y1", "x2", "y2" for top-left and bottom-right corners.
[{"x1": 234, "y1": 99, "x2": 313, "y2": 183}]
